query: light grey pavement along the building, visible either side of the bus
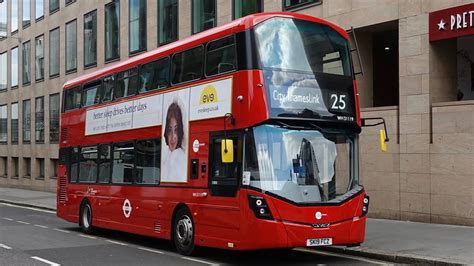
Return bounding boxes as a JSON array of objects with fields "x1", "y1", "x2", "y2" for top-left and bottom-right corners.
[{"x1": 0, "y1": 187, "x2": 474, "y2": 265}]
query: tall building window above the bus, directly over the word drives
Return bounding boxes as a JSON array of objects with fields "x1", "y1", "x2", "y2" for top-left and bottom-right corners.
[{"x1": 129, "y1": 0, "x2": 146, "y2": 54}]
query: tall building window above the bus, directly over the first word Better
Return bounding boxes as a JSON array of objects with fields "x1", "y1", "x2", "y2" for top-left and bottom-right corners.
[{"x1": 105, "y1": 1, "x2": 120, "y2": 61}]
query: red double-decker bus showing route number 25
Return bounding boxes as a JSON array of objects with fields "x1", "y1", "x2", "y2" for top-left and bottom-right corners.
[{"x1": 57, "y1": 13, "x2": 380, "y2": 254}]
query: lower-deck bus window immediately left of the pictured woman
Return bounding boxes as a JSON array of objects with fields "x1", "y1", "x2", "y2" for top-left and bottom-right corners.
[{"x1": 135, "y1": 139, "x2": 161, "y2": 185}]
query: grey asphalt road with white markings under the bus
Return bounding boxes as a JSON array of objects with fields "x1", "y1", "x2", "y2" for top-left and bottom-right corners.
[{"x1": 0, "y1": 203, "x2": 384, "y2": 265}]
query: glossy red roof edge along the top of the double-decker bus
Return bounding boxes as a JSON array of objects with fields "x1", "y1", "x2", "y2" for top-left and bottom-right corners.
[{"x1": 64, "y1": 12, "x2": 349, "y2": 90}]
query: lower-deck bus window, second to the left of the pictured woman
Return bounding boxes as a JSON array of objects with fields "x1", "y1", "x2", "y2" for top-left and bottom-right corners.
[{"x1": 112, "y1": 142, "x2": 135, "y2": 184}]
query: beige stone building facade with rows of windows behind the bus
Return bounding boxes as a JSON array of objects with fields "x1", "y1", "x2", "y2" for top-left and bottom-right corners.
[{"x1": 0, "y1": 0, "x2": 474, "y2": 226}]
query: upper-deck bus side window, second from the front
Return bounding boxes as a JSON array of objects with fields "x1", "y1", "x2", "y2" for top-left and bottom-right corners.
[{"x1": 171, "y1": 46, "x2": 204, "y2": 84}]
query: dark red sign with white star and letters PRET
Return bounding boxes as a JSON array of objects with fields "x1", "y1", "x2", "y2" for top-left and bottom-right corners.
[{"x1": 430, "y1": 4, "x2": 474, "y2": 41}]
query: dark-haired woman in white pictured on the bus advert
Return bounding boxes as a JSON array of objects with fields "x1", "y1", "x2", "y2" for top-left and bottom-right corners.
[{"x1": 162, "y1": 102, "x2": 187, "y2": 181}]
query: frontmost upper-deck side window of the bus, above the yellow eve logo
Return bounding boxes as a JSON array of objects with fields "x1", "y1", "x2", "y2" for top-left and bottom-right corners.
[{"x1": 206, "y1": 36, "x2": 237, "y2": 76}]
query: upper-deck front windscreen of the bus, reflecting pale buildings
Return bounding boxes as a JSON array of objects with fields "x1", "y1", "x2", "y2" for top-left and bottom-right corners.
[{"x1": 255, "y1": 18, "x2": 352, "y2": 76}]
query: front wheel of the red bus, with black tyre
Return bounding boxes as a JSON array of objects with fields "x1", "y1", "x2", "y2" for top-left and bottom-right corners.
[{"x1": 173, "y1": 208, "x2": 196, "y2": 256}]
